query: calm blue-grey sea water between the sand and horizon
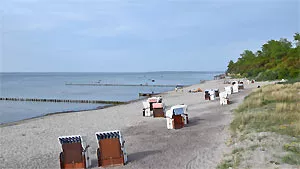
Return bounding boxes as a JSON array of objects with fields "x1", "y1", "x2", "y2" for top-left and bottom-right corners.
[{"x1": 0, "y1": 72, "x2": 220, "y2": 123}]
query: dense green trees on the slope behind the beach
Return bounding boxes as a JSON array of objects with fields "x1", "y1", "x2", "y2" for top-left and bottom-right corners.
[{"x1": 226, "y1": 33, "x2": 300, "y2": 80}]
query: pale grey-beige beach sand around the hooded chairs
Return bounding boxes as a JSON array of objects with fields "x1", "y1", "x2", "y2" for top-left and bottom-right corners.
[{"x1": 0, "y1": 80, "x2": 266, "y2": 169}]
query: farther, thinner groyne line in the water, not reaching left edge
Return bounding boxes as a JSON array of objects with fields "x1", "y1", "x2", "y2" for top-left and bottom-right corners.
[{"x1": 66, "y1": 83, "x2": 182, "y2": 87}]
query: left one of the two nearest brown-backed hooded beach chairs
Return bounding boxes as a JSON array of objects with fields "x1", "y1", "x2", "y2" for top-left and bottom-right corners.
[{"x1": 58, "y1": 135, "x2": 91, "y2": 169}]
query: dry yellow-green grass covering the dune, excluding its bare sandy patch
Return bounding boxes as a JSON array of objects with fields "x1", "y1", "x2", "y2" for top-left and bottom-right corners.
[{"x1": 230, "y1": 82, "x2": 300, "y2": 165}]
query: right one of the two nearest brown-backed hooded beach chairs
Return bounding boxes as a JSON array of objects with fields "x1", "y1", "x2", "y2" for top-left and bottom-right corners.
[{"x1": 95, "y1": 130, "x2": 127, "y2": 167}]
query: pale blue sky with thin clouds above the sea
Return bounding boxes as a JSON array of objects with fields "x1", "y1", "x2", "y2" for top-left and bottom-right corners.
[{"x1": 0, "y1": 0, "x2": 300, "y2": 72}]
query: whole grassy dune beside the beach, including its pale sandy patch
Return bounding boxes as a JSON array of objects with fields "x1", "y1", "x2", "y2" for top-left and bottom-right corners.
[{"x1": 218, "y1": 82, "x2": 300, "y2": 169}]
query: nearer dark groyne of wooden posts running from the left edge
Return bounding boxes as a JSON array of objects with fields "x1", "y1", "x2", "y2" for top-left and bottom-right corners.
[{"x1": 0, "y1": 97, "x2": 126, "y2": 105}]
